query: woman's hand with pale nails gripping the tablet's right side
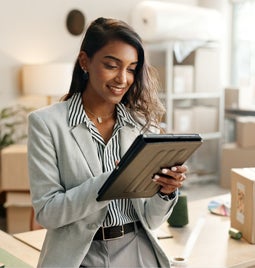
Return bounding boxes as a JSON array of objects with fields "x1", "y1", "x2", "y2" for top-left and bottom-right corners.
[{"x1": 153, "y1": 165, "x2": 188, "y2": 195}]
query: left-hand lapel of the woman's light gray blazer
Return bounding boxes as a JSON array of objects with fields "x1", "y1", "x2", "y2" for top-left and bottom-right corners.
[{"x1": 71, "y1": 124, "x2": 102, "y2": 176}]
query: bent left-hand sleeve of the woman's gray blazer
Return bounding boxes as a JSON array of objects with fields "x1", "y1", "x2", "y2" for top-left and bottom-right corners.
[{"x1": 28, "y1": 110, "x2": 109, "y2": 229}]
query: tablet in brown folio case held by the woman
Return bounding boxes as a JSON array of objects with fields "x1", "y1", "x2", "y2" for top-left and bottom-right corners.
[{"x1": 97, "y1": 134, "x2": 202, "y2": 201}]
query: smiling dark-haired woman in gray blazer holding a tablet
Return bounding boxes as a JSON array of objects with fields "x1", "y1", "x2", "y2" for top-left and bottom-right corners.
[{"x1": 28, "y1": 18, "x2": 187, "y2": 267}]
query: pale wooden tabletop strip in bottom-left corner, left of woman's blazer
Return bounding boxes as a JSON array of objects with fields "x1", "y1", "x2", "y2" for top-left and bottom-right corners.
[{"x1": 0, "y1": 230, "x2": 40, "y2": 267}]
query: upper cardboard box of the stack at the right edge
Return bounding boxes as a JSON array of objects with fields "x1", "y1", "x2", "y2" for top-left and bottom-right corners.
[{"x1": 236, "y1": 116, "x2": 255, "y2": 147}]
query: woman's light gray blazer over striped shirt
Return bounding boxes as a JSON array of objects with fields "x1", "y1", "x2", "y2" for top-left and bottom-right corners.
[{"x1": 28, "y1": 101, "x2": 176, "y2": 267}]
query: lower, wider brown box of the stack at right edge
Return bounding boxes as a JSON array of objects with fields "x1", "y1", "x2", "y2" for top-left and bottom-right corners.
[{"x1": 220, "y1": 143, "x2": 255, "y2": 189}]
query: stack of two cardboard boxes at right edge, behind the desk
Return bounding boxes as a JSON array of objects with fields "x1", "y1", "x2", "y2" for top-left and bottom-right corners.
[{"x1": 220, "y1": 116, "x2": 255, "y2": 189}]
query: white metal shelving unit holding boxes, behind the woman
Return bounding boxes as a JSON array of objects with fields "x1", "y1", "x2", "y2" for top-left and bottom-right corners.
[{"x1": 146, "y1": 42, "x2": 224, "y2": 179}]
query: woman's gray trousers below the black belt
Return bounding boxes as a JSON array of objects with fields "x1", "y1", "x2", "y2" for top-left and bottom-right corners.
[{"x1": 80, "y1": 225, "x2": 159, "y2": 268}]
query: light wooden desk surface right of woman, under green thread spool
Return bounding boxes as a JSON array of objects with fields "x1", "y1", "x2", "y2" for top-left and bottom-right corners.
[{"x1": 160, "y1": 195, "x2": 255, "y2": 268}]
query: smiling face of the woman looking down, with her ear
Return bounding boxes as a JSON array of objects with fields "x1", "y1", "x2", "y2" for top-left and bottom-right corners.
[{"x1": 80, "y1": 40, "x2": 138, "y2": 104}]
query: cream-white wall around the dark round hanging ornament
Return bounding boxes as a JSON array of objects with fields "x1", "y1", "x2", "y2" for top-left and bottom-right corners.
[{"x1": 0, "y1": 0, "x2": 231, "y2": 108}]
